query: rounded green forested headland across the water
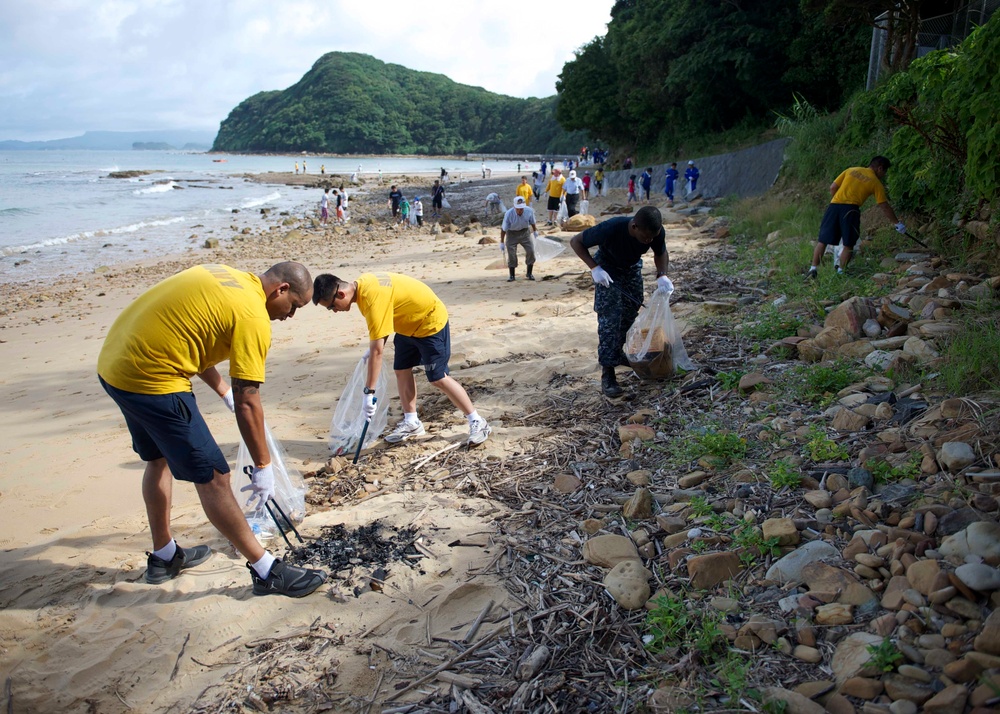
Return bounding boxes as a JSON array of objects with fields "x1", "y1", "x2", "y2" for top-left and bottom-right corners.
[{"x1": 213, "y1": 52, "x2": 587, "y2": 154}]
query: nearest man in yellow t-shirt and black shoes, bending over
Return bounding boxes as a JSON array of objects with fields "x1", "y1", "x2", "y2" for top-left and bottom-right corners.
[{"x1": 97, "y1": 262, "x2": 326, "y2": 597}]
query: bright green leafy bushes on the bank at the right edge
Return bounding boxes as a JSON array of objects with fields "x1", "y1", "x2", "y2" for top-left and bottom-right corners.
[{"x1": 785, "y1": 15, "x2": 1000, "y2": 218}]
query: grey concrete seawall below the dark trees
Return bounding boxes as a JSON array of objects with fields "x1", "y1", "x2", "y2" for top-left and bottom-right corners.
[{"x1": 592, "y1": 139, "x2": 791, "y2": 198}]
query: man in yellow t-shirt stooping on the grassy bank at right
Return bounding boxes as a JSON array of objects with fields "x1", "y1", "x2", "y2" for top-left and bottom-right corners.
[{"x1": 807, "y1": 156, "x2": 906, "y2": 278}]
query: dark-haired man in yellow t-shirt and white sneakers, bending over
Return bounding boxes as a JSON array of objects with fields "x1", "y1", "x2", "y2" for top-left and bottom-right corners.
[{"x1": 313, "y1": 273, "x2": 490, "y2": 446}]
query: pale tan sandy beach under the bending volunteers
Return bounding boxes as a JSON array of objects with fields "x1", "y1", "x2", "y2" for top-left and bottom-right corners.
[{"x1": 0, "y1": 174, "x2": 716, "y2": 713}]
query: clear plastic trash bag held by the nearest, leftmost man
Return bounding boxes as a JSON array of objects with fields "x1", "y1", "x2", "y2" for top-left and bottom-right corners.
[{"x1": 230, "y1": 422, "x2": 306, "y2": 538}]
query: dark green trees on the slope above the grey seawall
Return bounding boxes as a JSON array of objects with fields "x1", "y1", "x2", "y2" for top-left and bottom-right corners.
[{"x1": 556, "y1": 0, "x2": 871, "y2": 153}]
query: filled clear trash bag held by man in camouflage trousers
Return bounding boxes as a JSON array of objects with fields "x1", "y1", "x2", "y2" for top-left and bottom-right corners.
[{"x1": 625, "y1": 288, "x2": 694, "y2": 379}]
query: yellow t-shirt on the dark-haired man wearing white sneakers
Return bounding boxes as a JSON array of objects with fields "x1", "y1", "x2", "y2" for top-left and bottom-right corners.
[{"x1": 357, "y1": 273, "x2": 448, "y2": 340}]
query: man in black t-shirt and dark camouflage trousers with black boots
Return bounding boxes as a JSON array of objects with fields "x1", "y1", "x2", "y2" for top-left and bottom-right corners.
[{"x1": 570, "y1": 206, "x2": 672, "y2": 397}]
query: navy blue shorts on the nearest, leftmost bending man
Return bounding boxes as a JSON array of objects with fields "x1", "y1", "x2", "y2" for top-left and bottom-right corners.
[{"x1": 98, "y1": 376, "x2": 229, "y2": 483}]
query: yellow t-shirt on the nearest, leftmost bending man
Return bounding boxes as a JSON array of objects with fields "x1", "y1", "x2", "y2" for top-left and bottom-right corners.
[{"x1": 97, "y1": 265, "x2": 271, "y2": 394}]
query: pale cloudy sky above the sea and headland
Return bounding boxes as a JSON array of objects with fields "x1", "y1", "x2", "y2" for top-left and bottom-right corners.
[{"x1": 0, "y1": 0, "x2": 613, "y2": 141}]
